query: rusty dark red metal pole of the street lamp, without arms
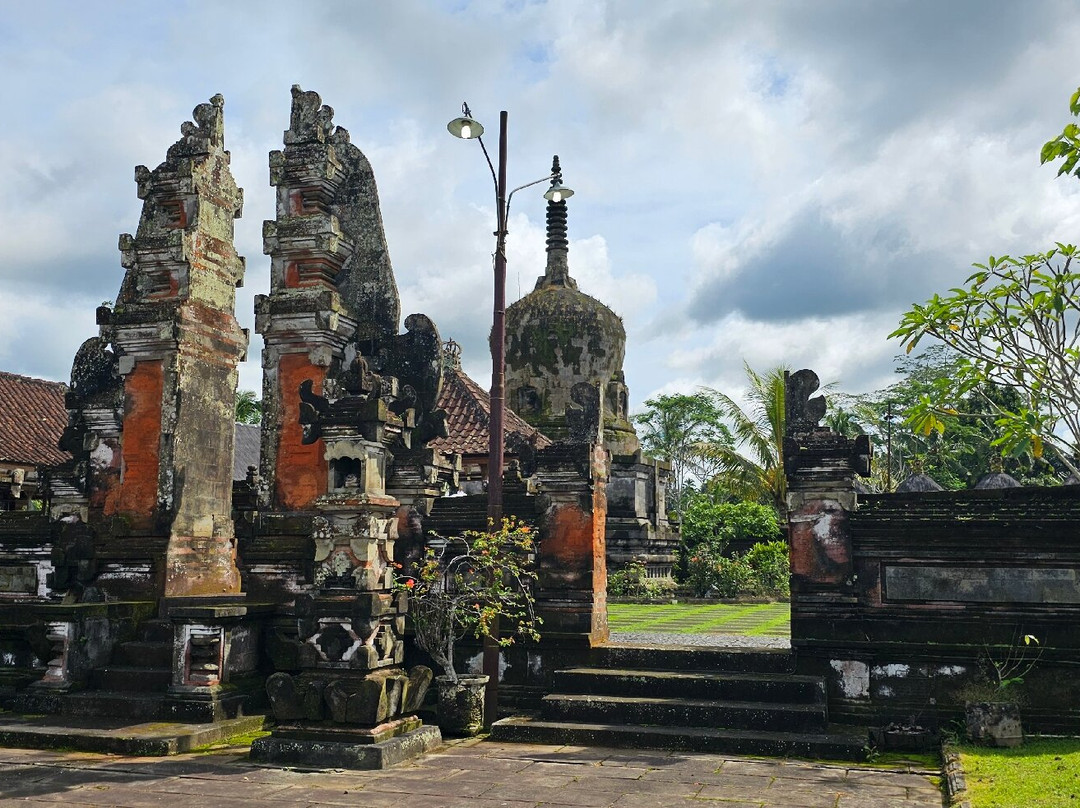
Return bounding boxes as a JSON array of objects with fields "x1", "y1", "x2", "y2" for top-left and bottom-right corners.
[{"x1": 484, "y1": 110, "x2": 507, "y2": 726}]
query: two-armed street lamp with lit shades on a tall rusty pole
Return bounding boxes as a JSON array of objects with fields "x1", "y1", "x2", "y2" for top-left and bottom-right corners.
[{"x1": 446, "y1": 103, "x2": 573, "y2": 726}]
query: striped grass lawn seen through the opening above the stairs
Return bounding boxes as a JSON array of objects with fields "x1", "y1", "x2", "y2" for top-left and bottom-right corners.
[{"x1": 608, "y1": 603, "x2": 792, "y2": 637}]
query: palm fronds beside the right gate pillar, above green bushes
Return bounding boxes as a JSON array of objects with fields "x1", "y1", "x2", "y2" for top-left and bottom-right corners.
[{"x1": 698, "y1": 364, "x2": 787, "y2": 514}]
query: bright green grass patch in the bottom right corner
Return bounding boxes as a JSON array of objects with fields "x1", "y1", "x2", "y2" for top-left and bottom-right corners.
[{"x1": 955, "y1": 738, "x2": 1080, "y2": 808}]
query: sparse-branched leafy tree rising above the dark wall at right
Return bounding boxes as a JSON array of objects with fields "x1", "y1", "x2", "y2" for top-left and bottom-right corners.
[{"x1": 890, "y1": 243, "x2": 1080, "y2": 473}]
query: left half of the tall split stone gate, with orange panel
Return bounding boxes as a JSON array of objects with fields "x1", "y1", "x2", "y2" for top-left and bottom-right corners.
[{"x1": 52, "y1": 95, "x2": 247, "y2": 597}]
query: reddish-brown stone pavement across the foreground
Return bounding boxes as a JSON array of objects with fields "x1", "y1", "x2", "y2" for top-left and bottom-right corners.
[{"x1": 0, "y1": 741, "x2": 942, "y2": 808}]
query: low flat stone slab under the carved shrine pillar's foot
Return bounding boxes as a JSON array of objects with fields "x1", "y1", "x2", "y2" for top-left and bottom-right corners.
[{"x1": 251, "y1": 716, "x2": 443, "y2": 769}]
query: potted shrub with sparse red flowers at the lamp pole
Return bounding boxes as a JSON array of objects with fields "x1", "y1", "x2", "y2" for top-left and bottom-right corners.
[{"x1": 395, "y1": 516, "x2": 540, "y2": 682}]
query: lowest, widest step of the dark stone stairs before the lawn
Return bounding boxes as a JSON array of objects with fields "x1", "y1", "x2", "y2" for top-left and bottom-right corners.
[{"x1": 490, "y1": 716, "x2": 867, "y2": 760}]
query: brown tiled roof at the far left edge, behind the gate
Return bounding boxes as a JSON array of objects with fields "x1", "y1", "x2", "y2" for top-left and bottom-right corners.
[{"x1": 0, "y1": 371, "x2": 70, "y2": 466}]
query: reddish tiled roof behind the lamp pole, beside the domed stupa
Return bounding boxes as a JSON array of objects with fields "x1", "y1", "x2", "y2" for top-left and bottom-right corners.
[{"x1": 428, "y1": 367, "x2": 551, "y2": 455}]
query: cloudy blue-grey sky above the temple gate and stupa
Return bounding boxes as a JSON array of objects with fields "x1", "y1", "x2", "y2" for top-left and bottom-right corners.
[{"x1": 0, "y1": 0, "x2": 1080, "y2": 407}]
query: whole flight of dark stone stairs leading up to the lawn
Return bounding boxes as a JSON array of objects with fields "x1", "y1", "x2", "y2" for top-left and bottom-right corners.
[{"x1": 491, "y1": 645, "x2": 868, "y2": 760}]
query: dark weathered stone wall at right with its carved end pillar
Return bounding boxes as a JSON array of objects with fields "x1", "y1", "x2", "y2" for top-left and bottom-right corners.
[{"x1": 785, "y1": 372, "x2": 1080, "y2": 732}]
